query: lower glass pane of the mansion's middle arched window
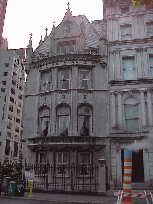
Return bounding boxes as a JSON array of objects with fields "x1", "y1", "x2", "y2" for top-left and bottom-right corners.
[{"x1": 59, "y1": 116, "x2": 69, "y2": 136}]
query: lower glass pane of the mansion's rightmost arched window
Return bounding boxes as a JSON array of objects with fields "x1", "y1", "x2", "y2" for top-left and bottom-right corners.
[{"x1": 79, "y1": 116, "x2": 89, "y2": 136}]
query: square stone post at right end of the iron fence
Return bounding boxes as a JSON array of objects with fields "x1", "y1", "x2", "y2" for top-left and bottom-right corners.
[{"x1": 98, "y1": 159, "x2": 106, "y2": 195}]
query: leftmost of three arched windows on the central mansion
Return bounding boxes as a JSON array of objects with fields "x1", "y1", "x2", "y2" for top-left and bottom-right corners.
[{"x1": 39, "y1": 108, "x2": 49, "y2": 136}]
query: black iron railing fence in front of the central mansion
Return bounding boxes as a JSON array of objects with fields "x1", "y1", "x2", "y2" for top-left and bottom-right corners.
[{"x1": 0, "y1": 163, "x2": 99, "y2": 193}]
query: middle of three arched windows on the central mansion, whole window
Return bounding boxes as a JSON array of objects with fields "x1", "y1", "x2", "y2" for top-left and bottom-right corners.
[{"x1": 57, "y1": 107, "x2": 70, "y2": 136}]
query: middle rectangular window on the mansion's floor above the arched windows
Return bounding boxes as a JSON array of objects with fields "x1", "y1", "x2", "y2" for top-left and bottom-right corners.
[{"x1": 60, "y1": 70, "x2": 70, "y2": 89}]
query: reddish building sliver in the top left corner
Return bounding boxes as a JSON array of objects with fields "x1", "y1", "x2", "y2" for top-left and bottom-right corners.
[{"x1": 0, "y1": 0, "x2": 7, "y2": 47}]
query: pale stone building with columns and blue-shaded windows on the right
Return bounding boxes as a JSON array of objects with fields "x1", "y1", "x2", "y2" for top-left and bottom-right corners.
[{"x1": 104, "y1": 0, "x2": 153, "y2": 187}]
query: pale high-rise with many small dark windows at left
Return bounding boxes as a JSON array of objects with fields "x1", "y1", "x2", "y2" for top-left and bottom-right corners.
[{"x1": 0, "y1": 50, "x2": 25, "y2": 163}]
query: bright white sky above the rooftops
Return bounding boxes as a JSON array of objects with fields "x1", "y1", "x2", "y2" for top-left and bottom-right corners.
[{"x1": 3, "y1": 0, "x2": 103, "y2": 49}]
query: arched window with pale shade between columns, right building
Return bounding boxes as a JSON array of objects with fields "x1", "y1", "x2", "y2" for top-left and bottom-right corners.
[{"x1": 124, "y1": 97, "x2": 139, "y2": 132}]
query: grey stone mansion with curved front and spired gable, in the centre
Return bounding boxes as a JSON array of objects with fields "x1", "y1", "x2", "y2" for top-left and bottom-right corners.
[{"x1": 24, "y1": 5, "x2": 110, "y2": 191}]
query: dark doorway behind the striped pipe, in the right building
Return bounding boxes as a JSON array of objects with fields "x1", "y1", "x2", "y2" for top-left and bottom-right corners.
[{"x1": 121, "y1": 150, "x2": 144, "y2": 183}]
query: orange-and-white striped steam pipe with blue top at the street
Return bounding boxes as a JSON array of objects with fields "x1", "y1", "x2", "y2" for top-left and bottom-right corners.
[{"x1": 122, "y1": 149, "x2": 132, "y2": 204}]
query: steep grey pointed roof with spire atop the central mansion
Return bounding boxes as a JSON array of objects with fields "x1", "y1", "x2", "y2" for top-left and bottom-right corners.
[{"x1": 33, "y1": 2, "x2": 103, "y2": 54}]
